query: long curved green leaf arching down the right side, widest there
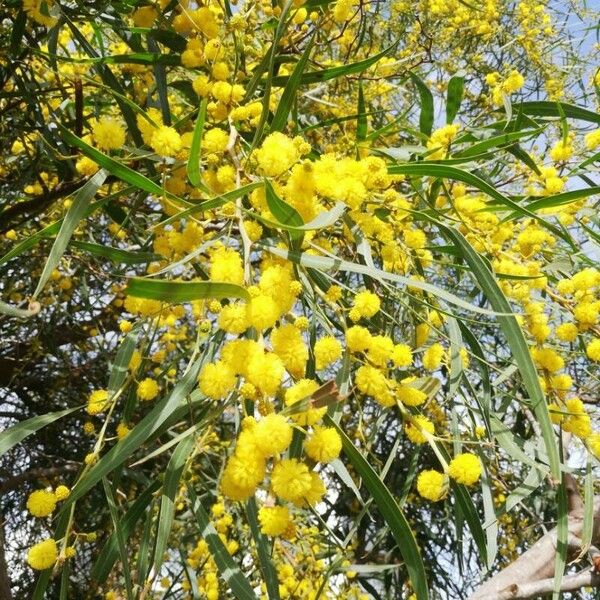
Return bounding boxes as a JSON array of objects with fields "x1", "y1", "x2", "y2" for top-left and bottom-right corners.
[{"x1": 438, "y1": 223, "x2": 561, "y2": 480}]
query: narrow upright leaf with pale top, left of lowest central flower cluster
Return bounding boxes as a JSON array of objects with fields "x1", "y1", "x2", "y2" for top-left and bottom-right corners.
[{"x1": 154, "y1": 435, "x2": 195, "y2": 573}]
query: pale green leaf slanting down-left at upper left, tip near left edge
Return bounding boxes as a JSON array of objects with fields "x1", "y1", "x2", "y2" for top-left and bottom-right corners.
[{"x1": 31, "y1": 169, "x2": 108, "y2": 300}]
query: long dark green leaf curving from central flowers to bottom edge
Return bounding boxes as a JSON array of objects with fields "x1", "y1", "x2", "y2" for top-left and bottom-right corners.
[{"x1": 323, "y1": 415, "x2": 429, "y2": 600}]
